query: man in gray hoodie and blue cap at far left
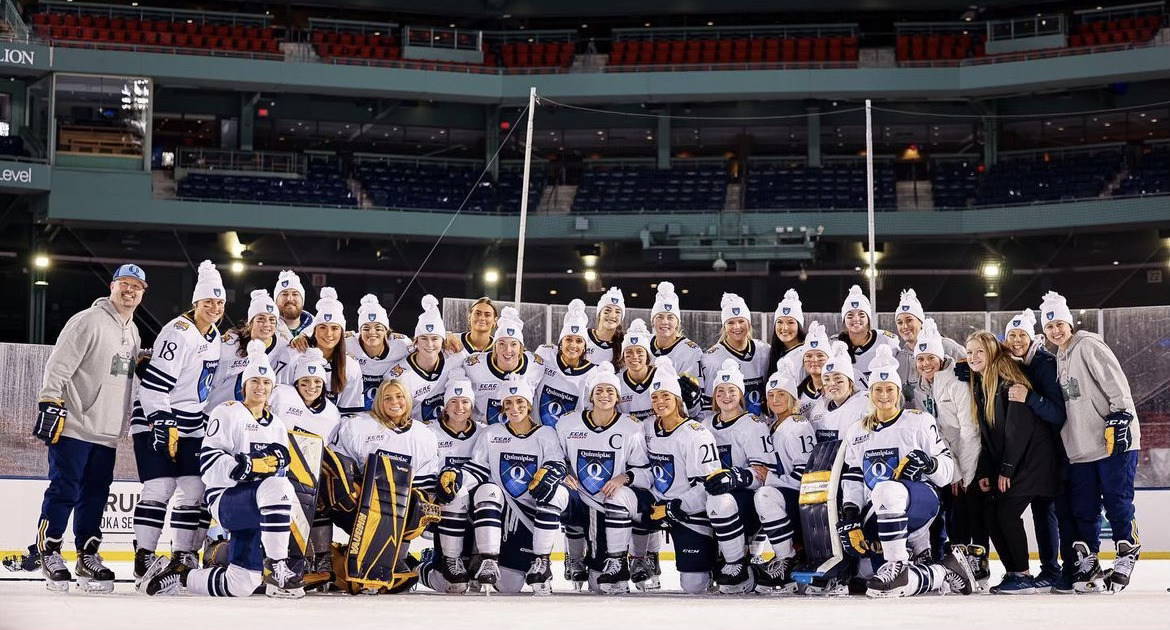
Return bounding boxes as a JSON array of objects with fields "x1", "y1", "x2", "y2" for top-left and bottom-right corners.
[{"x1": 33, "y1": 265, "x2": 146, "y2": 593}]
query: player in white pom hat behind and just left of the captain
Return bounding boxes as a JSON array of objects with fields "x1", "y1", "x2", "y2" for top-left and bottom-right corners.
[{"x1": 536, "y1": 300, "x2": 597, "y2": 426}]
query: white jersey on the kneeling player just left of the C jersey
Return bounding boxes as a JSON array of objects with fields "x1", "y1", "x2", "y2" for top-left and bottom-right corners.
[{"x1": 463, "y1": 423, "x2": 565, "y2": 508}]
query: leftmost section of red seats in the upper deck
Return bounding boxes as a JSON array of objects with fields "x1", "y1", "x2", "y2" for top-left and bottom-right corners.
[{"x1": 33, "y1": 13, "x2": 281, "y2": 55}]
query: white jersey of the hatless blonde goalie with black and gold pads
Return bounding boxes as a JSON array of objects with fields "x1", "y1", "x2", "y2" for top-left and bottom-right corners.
[{"x1": 332, "y1": 411, "x2": 439, "y2": 492}]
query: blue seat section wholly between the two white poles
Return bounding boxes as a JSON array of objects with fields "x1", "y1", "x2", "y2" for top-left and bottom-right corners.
[{"x1": 573, "y1": 165, "x2": 728, "y2": 212}]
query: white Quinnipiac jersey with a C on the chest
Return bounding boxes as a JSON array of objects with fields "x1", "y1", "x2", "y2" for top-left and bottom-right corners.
[{"x1": 557, "y1": 411, "x2": 653, "y2": 497}]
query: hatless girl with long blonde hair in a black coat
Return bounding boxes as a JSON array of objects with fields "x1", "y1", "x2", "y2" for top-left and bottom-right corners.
[{"x1": 966, "y1": 330, "x2": 1060, "y2": 595}]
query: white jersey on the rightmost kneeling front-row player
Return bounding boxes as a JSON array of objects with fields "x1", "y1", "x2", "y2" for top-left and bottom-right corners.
[{"x1": 841, "y1": 409, "x2": 955, "y2": 509}]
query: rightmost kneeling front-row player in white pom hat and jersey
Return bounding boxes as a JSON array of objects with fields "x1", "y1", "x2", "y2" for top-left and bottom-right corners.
[{"x1": 837, "y1": 345, "x2": 975, "y2": 597}]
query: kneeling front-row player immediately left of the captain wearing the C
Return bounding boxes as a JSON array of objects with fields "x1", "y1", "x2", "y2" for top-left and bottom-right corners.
[{"x1": 439, "y1": 372, "x2": 569, "y2": 595}]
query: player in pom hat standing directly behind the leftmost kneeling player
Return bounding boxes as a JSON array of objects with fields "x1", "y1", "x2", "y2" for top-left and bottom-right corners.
[{"x1": 206, "y1": 289, "x2": 293, "y2": 409}]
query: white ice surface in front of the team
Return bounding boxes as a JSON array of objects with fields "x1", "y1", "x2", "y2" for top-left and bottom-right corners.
[{"x1": 0, "y1": 560, "x2": 1170, "y2": 630}]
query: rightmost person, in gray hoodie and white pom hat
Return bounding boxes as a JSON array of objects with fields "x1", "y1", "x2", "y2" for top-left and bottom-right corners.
[{"x1": 1040, "y1": 292, "x2": 1142, "y2": 593}]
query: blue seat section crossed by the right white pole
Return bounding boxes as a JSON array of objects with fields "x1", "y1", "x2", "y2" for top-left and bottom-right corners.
[{"x1": 744, "y1": 164, "x2": 897, "y2": 211}]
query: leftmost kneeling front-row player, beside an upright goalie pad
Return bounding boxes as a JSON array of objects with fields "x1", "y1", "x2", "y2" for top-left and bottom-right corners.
[{"x1": 139, "y1": 340, "x2": 304, "y2": 598}]
